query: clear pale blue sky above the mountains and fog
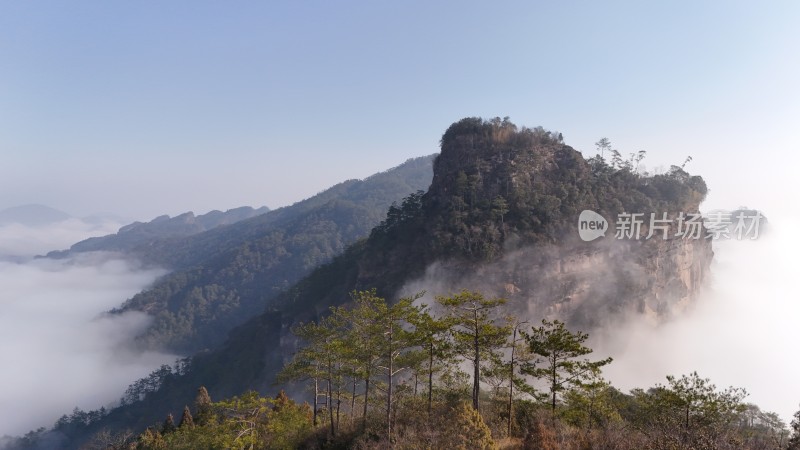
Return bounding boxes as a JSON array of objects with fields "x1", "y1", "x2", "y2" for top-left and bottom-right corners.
[{"x1": 0, "y1": 1, "x2": 800, "y2": 219}]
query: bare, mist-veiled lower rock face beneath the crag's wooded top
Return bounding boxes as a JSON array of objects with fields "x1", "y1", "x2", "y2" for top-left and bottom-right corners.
[{"x1": 402, "y1": 224, "x2": 713, "y2": 331}]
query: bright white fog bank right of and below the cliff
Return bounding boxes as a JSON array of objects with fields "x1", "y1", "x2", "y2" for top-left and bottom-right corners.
[{"x1": 594, "y1": 211, "x2": 800, "y2": 423}]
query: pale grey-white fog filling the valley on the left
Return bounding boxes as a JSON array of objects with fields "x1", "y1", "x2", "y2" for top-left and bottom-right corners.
[{"x1": 0, "y1": 218, "x2": 175, "y2": 436}]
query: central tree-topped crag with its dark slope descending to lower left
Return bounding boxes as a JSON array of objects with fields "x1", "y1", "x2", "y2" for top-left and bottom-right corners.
[{"x1": 50, "y1": 118, "x2": 712, "y2": 446}]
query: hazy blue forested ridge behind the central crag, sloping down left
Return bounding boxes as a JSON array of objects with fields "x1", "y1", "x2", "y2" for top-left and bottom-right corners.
[{"x1": 112, "y1": 156, "x2": 433, "y2": 354}]
